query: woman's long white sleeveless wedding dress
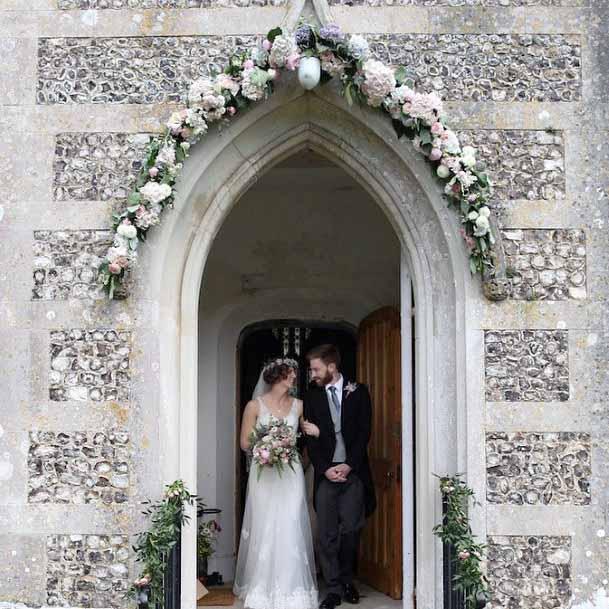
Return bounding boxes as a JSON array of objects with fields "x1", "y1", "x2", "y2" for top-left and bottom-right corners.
[{"x1": 233, "y1": 398, "x2": 317, "y2": 609}]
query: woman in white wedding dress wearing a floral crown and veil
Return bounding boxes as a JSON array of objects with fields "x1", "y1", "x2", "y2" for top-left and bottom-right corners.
[{"x1": 233, "y1": 359, "x2": 317, "y2": 609}]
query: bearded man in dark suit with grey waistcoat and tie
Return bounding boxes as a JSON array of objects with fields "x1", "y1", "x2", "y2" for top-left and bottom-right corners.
[{"x1": 303, "y1": 345, "x2": 376, "y2": 609}]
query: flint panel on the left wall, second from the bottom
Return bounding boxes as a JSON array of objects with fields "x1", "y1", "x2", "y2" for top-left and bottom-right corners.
[{"x1": 28, "y1": 430, "x2": 130, "y2": 504}]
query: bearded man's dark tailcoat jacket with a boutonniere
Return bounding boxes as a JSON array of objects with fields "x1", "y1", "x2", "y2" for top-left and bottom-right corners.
[{"x1": 304, "y1": 379, "x2": 376, "y2": 516}]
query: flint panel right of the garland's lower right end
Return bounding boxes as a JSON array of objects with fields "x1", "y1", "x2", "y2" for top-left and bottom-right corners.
[{"x1": 501, "y1": 229, "x2": 587, "y2": 300}]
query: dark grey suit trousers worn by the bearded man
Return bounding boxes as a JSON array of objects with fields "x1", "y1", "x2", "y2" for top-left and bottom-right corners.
[{"x1": 315, "y1": 473, "x2": 366, "y2": 594}]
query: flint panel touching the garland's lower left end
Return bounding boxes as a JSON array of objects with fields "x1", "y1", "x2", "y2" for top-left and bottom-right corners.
[{"x1": 32, "y1": 230, "x2": 113, "y2": 300}]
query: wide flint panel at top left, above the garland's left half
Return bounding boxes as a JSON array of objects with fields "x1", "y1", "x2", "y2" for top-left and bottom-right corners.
[{"x1": 37, "y1": 36, "x2": 255, "y2": 104}]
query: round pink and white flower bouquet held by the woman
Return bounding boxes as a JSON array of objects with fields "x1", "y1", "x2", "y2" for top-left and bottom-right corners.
[{"x1": 249, "y1": 417, "x2": 299, "y2": 479}]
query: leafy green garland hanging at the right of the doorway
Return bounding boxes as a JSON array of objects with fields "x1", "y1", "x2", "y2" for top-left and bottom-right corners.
[{"x1": 433, "y1": 474, "x2": 490, "y2": 609}]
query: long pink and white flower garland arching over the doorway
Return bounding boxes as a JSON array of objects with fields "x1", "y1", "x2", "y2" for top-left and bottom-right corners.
[{"x1": 99, "y1": 24, "x2": 494, "y2": 298}]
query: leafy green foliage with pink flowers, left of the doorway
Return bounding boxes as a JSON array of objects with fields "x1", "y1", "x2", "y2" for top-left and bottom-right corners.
[{"x1": 129, "y1": 480, "x2": 196, "y2": 607}]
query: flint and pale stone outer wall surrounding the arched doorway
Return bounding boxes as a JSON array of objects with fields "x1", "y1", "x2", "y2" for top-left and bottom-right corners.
[{"x1": 0, "y1": 0, "x2": 609, "y2": 609}]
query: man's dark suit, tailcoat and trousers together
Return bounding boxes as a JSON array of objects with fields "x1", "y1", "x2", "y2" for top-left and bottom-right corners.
[{"x1": 304, "y1": 379, "x2": 376, "y2": 594}]
